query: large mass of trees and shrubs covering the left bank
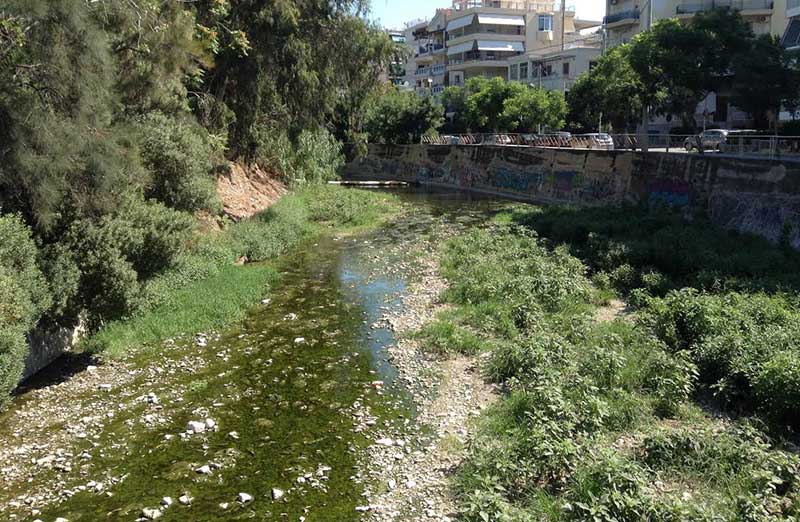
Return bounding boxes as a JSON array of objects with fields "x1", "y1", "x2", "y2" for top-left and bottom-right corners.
[{"x1": 0, "y1": 0, "x2": 395, "y2": 406}]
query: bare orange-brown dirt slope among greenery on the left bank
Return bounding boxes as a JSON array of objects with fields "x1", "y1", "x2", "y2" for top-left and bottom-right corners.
[{"x1": 217, "y1": 162, "x2": 289, "y2": 221}]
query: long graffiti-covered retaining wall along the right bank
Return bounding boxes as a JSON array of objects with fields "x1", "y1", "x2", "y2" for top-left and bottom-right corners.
[{"x1": 344, "y1": 145, "x2": 800, "y2": 247}]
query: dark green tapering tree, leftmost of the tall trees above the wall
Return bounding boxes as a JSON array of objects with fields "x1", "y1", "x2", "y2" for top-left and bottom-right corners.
[{"x1": 567, "y1": 44, "x2": 643, "y2": 132}]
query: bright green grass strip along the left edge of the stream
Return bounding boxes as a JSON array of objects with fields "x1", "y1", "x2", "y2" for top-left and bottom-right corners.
[{"x1": 82, "y1": 185, "x2": 398, "y2": 358}]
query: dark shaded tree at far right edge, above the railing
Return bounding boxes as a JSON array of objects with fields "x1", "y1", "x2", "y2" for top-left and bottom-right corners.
[{"x1": 733, "y1": 35, "x2": 800, "y2": 129}]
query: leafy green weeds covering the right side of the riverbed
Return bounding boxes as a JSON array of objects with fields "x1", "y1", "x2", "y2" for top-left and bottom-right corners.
[{"x1": 432, "y1": 218, "x2": 800, "y2": 522}]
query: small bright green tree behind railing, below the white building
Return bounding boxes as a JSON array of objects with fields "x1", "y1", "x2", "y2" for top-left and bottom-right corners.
[{"x1": 501, "y1": 87, "x2": 567, "y2": 132}]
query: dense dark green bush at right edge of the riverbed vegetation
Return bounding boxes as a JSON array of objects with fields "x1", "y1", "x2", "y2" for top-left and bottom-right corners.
[{"x1": 640, "y1": 290, "x2": 800, "y2": 425}]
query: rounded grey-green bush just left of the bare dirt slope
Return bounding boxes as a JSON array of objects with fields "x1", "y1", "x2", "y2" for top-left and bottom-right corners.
[{"x1": 136, "y1": 112, "x2": 222, "y2": 214}]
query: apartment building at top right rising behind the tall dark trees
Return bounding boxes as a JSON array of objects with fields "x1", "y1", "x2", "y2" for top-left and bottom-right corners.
[{"x1": 603, "y1": 0, "x2": 798, "y2": 46}]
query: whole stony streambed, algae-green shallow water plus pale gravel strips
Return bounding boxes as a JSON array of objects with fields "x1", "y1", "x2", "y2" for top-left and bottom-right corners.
[{"x1": 0, "y1": 189, "x2": 510, "y2": 522}]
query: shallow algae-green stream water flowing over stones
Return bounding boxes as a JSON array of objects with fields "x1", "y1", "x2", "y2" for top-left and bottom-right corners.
[{"x1": 26, "y1": 192, "x2": 502, "y2": 522}]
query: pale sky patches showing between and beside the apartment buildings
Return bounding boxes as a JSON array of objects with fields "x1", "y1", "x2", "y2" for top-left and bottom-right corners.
[{"x1": 372, "y1": 0, "x2": 606, "y2": 29}]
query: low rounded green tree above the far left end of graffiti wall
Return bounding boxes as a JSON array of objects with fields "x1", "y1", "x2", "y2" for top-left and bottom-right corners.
[{"x1": 365, "y1": 87, "x2": 444, "y2": 143}]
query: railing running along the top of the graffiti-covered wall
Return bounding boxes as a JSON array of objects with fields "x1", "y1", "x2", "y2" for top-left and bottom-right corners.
[{"x1": 422, "y1": 133, "x2": 800, "y2": 159}]
